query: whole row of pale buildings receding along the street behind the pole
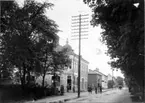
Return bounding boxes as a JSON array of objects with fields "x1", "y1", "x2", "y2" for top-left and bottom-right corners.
[{"x1": 39, "y1": 43, "x2": 116, "y2": 91}]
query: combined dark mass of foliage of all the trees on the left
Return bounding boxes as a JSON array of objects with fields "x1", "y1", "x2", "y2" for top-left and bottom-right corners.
[{"x1": 0, "y1": 0, "x2": 71, "y2": 92}]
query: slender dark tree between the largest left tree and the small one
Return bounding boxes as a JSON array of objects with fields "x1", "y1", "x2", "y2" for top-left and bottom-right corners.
[{"x1": 35, "y1": 38, "x2": 54, "y2": 87}]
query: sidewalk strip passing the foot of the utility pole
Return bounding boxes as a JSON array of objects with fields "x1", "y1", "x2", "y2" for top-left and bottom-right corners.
[{"x1": 25, "y1": 89, "x2": 112, "y2": 103}]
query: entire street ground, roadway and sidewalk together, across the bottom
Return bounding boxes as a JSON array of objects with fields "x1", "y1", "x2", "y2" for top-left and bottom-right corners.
[{"x1": 25, "y1": 88, "x2": 143, "y2": 103}]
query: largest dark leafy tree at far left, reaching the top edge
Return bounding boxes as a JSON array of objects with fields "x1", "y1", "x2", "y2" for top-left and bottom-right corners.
[{"x1": 0, "y1": 0, "x2": 58, "y2": 87}]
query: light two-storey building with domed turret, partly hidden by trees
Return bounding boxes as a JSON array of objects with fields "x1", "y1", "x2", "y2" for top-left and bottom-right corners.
[{"x1": 37, "y1": 43, "x2": 89, "y2": 91}]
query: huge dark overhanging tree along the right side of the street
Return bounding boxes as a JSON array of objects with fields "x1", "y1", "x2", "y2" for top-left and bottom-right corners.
[{"x1": 84, "y1": 0, "x2": 144, "y2": 87}]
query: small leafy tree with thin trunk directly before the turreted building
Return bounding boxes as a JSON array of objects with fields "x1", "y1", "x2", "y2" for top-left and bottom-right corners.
[{"x1": 51, "y1": 46, "x2": 71, "y2": 93}]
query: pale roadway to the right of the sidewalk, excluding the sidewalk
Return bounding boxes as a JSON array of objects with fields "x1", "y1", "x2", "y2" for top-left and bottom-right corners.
[{"x1": 66, "y1": 88, "x2": 134, "y2": 103}]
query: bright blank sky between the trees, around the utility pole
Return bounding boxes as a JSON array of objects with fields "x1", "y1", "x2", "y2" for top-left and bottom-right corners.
[{"x1": 17, "y1": 0, "x2": 123, "y2": 77}]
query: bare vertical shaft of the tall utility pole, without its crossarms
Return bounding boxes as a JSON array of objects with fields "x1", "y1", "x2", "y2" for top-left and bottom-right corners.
[{"x1": 78, "y1": 14, "x2": 81, "y2": 98}]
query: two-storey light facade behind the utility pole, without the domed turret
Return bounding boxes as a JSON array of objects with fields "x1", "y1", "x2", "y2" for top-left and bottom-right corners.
[{"x1": 61, "y1": 53, "x2": 89, "y2": 91}]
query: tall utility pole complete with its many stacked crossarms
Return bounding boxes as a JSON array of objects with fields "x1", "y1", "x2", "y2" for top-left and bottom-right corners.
[{"x1": 71, "y1": 14, "x2": 89, "y2": 98}]
